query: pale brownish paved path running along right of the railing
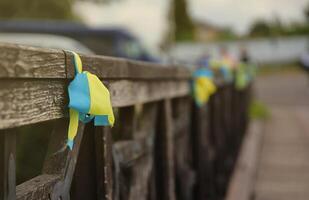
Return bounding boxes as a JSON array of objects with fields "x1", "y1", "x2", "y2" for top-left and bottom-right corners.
[{"x1": 254, "y1": 73, "x2": 309, "y2": 200}]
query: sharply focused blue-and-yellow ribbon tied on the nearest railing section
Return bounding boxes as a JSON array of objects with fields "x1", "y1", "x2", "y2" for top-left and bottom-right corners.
[{"x1": 67, "y1": 52, "x2": 115, "y2": 150}]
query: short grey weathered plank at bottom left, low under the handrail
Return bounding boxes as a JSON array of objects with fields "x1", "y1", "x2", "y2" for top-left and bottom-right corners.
[{"x1": 16, "y1": 174, "x2": 61, "y2": 200}]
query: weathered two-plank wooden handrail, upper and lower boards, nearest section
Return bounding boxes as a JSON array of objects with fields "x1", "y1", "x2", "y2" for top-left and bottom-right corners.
[{"x1": 0, "y1": 44, "x2": 190, "y2": 130}]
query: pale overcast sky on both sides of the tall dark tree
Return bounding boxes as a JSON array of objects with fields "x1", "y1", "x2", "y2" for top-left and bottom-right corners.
[{"x1": 75, "y1": 0, "x2": 309, "y2": 47}]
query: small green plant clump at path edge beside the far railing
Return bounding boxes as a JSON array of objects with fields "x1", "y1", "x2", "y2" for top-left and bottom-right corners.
[{"x1": 249, "y1": 100, "x2": 270, "y2": 119}]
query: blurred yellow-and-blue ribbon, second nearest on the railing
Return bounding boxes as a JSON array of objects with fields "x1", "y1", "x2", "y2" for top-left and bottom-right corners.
[{"x1": 192, "y1": 68, "x2": 217, "y2": 107}]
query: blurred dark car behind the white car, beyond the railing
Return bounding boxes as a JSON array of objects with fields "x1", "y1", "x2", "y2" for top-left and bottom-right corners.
[{"x1": 0, "y1": 20, "x2": 159, "y2": 62}]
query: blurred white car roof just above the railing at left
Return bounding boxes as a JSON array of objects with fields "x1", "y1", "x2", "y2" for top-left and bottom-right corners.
[{"x1": 0, "y1": 33, "x2": 95, "y2": 54}]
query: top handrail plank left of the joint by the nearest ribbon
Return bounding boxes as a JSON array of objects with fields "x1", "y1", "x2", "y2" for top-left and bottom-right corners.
[{"x1": 0, "y1": 43, "x2": 66, "y2": 78}]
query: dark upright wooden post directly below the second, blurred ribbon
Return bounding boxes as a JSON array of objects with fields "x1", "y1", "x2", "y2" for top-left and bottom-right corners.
[{"x1": 191, "y1": 101, "x2": 216, "y2": 200}]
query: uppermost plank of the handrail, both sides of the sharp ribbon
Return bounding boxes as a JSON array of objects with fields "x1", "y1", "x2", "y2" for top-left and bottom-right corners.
[{"x1": 0, "y1": 43, "x2": 190, "y2": 79}]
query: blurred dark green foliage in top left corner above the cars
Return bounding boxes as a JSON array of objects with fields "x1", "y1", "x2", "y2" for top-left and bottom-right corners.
[{"x1": 0, "y1": 0, "x2": 75, "y2": 19}]
